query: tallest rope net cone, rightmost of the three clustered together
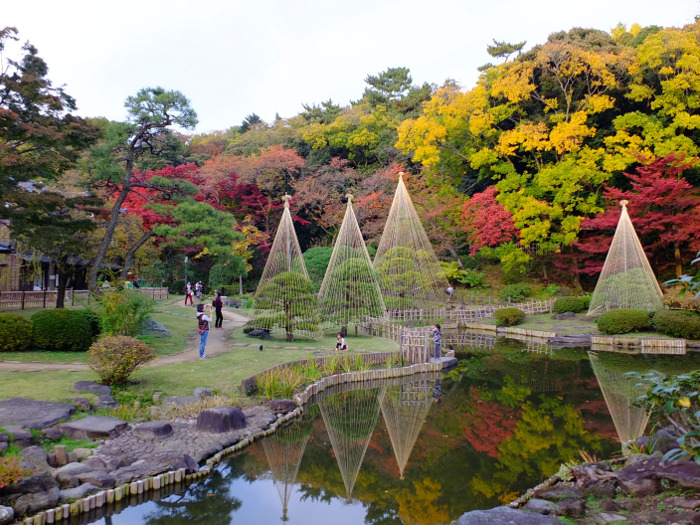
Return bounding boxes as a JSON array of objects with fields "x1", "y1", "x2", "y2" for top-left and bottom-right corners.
[{"x1": 374, "y1": 173, "x2": 449, "y2": 310}]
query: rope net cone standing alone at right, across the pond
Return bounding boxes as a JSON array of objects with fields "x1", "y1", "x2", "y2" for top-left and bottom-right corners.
[{"x1": 588, "y1": 201, "x2": 663, "y2": 315}]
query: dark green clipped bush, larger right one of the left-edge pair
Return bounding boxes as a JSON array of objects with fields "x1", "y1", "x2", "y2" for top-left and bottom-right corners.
[{"x1": 32, "y1": 308, "x2": 95, "y2": 352}]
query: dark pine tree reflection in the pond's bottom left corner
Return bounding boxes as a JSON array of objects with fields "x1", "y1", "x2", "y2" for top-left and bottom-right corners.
[{"x1": 144, "y1": 466, "x2": 242, "y2": 525}]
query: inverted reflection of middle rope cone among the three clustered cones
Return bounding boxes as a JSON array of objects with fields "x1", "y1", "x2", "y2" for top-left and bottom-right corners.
[{"x1": 319, "y1": 388, "x2": 385, "y2": 500}]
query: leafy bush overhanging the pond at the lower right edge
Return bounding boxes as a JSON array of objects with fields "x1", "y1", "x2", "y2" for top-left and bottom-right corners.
[{"x1": 637, "y1": 370, "x2": 700, "y2": 465}]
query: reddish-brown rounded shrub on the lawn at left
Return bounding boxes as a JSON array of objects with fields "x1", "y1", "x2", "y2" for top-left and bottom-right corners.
[{"x1": 88, "y1": 336, "x2": 157, "y2": 385}]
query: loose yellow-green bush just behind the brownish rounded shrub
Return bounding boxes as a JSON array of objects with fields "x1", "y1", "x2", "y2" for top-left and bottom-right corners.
[{"x1": 99, "y1": 290, "x2": 155, "y2": 337}]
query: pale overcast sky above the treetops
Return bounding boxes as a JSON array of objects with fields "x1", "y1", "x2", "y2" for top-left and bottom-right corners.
[{"x1": 5, "y1": 0, "x2": 700, "y2": 132}]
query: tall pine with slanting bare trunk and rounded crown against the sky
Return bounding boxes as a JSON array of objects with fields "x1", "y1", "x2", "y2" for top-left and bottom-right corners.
[{"x1": 88, "y1": 87, "x2": 197, "y2": 290}]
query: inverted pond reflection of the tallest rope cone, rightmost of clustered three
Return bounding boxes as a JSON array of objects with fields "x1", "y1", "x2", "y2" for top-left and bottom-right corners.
[{"x1": 381, "y1": 380, "x2": 435, "y2": 479}]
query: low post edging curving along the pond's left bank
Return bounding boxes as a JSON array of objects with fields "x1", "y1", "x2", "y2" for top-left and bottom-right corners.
[{"x1": 19, "y1": 360, "x2": 448, "y2": 525}]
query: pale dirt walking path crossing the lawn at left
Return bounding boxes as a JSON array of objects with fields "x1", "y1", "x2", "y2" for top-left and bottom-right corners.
[{"x1": 0, "y1": 299, "x2": 248, "y2": 372}]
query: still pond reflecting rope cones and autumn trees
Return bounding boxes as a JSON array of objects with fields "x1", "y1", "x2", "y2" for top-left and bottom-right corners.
[{"x1": 82, "y1": 336, "x2": 700, "y2": 525}]
